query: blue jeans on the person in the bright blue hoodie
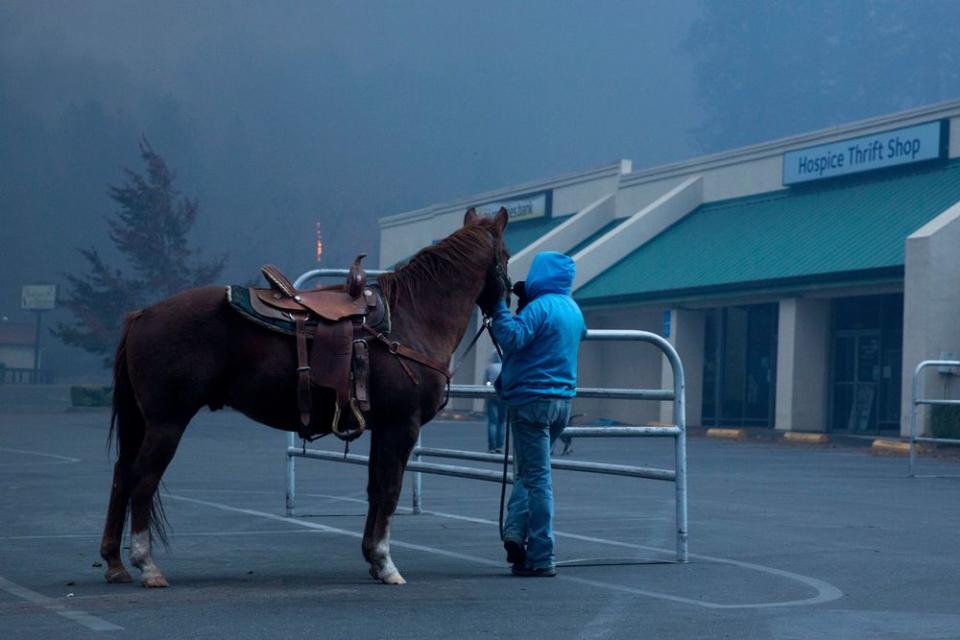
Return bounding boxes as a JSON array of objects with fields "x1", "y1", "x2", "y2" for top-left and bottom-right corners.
[{"x1": 503, "y1": 398, "x2": 570, "y2": 569}]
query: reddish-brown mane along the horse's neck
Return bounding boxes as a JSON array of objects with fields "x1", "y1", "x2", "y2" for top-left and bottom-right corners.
[{"x1": 378, "y1": 221, "x2": 493, "y2": 307}]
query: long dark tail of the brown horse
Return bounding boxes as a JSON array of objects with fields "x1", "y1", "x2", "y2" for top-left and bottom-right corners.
[{"x1": 107, "y1": 311, "x2": 167, "y2": 544}]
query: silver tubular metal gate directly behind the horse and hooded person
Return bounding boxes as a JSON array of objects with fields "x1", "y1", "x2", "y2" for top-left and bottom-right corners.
[{"x1": 286, "y1": 269, "x2": 688, "y2": 562}]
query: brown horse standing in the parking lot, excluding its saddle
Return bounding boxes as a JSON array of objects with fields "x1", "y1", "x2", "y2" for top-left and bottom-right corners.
[{"x1": 100, "y1": 209, "x2": 509, "y2": 587}]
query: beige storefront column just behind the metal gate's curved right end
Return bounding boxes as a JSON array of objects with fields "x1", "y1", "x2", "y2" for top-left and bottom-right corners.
[{"x1": 660, "y1": 309, "x2": 706, "y2": 426}]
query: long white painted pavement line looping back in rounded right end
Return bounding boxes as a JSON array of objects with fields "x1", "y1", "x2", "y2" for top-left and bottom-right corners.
[{"x1": 164, "y1": 493, "x2": 843, "y2": 609}]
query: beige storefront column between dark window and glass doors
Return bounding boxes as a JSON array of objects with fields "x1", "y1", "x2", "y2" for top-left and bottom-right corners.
[{"x1": 775, "y1": 298, "x2": 830, "y2": 431}]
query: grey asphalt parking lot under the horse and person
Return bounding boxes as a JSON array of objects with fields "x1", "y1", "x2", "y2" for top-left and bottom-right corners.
[{"x1": 0, "y1": 411, "x2": 960, "y2": 640}]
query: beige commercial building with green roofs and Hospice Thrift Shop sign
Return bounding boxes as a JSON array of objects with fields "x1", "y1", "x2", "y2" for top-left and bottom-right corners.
[{"x1": 380, "y1": 101, "x2": 960, "y2": 434}]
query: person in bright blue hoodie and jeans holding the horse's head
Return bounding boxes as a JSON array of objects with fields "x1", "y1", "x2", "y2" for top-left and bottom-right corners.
[{"x1": 490, "y1": 251, "x2": 586, "y2": 577}]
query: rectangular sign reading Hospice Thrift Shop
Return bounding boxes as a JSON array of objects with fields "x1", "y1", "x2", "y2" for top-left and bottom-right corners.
[{"x1": 783, "y1": 120, "x2": 947, "y2": 185}]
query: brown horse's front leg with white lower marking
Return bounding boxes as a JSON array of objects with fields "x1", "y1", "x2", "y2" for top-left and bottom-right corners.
[{"x1": 363, "y1": 424, "x2": 419, "y2": 584}]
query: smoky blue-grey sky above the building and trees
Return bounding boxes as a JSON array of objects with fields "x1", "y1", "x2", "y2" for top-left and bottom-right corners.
[{"x1": 0, "y1": 0, "x2": 960, "y2": 380}]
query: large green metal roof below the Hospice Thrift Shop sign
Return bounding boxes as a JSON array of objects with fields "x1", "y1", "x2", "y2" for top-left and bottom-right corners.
[{"x1": 575, "y1": 161, "x2": 960, "y2": 304}]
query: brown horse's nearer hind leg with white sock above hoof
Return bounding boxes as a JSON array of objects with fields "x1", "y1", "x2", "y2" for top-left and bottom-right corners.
[{"x1": 130, "y1": 422, "x2": 186, "y2": 587}]
